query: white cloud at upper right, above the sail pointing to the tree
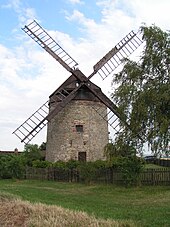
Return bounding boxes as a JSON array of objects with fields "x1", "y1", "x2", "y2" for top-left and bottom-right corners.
[{"x1": 66, "y1": 0, "x2": 170, "y2": 70}]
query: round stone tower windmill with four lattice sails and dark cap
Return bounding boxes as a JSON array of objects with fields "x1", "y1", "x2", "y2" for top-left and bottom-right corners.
[{"x1": 13, "y1": 20, "x2": 143, "y2": 162}]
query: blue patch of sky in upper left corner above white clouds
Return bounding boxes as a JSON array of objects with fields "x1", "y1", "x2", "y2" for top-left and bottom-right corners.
[{"x1": 0, "y1": 0, "x2": 102, "y2": 45}]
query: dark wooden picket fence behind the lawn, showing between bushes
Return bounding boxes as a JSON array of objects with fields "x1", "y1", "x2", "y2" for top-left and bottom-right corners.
[{"x1": 25, "y1": 167, "x2": 170, "y2": 185}]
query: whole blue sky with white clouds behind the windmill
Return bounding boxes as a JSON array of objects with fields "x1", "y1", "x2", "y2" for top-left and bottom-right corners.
[{"x1": 0, "y1": 0, "x2": 170, "y2": 151}]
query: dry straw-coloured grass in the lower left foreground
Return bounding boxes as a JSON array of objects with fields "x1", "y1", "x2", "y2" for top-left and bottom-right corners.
[{"x1": 0, "y1": 194, "x2": 136, "y2": 227}]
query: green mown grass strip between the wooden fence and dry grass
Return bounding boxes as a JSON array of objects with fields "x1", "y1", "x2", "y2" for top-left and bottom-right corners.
[{"x1": 0, "y1": 180, "x2": 170, "y2": 227}]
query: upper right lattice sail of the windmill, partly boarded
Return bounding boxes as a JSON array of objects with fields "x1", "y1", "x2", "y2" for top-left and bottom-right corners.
[{"x1": 88, "y1": 31, "x2": 143, "y2": 80}]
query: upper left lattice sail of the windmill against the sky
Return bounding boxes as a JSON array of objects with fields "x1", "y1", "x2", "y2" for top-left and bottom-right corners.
[{"x1": 22, "y1": 20, "x2": 78, "y2": 72}]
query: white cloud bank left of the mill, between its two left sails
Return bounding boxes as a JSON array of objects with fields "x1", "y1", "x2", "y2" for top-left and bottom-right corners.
[{"x1": 0, "y1": 36, "x2": 68, "y2": 149}]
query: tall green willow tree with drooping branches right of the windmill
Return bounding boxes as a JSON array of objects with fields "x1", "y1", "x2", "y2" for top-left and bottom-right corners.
[{"x1": 112, "y1": 25, "x2": 170, "y2": 156}]
